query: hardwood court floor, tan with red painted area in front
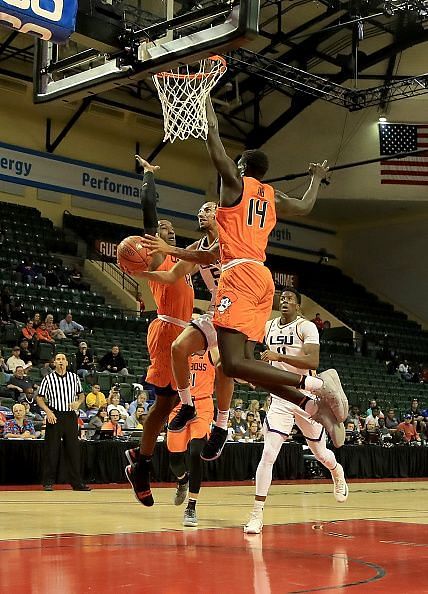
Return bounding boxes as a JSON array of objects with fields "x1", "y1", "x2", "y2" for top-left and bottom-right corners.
[{"x1": 0, "y1": 481, "x2": 428, "y2": 594}]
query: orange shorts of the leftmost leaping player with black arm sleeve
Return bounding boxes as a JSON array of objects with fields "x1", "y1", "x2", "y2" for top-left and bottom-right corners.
[{"x1": 146, "y1": 318, "x2": 184, "y2": 390}]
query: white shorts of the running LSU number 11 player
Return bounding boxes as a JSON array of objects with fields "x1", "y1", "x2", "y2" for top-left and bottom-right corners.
[{"x1": 263, "y1": 390, "x2": 324, "y2": 441}]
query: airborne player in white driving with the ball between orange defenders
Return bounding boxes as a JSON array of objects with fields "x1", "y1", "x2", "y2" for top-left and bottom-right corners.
[{"x1": 139, "y1": 202, "x2": 234, "y2": 460}]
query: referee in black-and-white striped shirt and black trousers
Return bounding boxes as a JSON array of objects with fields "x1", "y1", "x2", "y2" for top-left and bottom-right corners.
[{"x1": 37, "y1": 353, "x2": 90, "y2": 491}]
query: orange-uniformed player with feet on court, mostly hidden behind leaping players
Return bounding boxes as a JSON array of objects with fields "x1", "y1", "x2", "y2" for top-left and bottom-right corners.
[{"x1": 166, "y1": 348, "x2": 218, "y2": 526}]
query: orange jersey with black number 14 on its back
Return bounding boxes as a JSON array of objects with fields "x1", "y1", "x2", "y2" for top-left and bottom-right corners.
[{"x1": 216, "y1": 177, "x2": 276, "y2": 264}]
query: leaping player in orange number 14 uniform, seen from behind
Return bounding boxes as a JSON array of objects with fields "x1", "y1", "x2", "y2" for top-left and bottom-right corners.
[{"x1": 199, "y1": 97, "x2": 348, "y2": 456}]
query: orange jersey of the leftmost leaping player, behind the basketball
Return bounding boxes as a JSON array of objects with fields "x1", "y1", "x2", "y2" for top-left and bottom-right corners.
[{"x1": 149, "y1": 255, "x2": 194, "y2": 322}]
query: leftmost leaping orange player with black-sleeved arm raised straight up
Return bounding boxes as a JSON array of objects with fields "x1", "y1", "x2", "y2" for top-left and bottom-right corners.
[{"x1": 126, "y1": 156, "x2": 194, "y2": 506}]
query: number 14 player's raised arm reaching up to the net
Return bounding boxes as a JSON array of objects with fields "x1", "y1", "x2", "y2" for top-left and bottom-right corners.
[{"x1": 206, "y1": 95, "x2": 242, "y2": 192}]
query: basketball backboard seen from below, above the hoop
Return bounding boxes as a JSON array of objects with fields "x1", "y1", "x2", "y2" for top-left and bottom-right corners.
[{"x1": 33, "y1": 0, "x2": 259, "y2": 103}]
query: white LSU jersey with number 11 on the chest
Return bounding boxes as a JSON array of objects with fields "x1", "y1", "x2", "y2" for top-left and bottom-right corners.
[{"x1": 265, "y1": 316, "x2": 320, "y2": 375}]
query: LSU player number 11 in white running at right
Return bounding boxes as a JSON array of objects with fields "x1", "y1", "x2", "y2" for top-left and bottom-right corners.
[{"x1": 244, "y1": 288, "x2": 348, "y2": 534}]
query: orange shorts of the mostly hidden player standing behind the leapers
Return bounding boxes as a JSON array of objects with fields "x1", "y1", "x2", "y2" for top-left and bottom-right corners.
[{"x1": 166, "y1": 396, "x2": 214, "y2": 452}]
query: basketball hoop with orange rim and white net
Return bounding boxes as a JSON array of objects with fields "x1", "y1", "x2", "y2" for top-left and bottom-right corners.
[{"x1": 152, "y1": 56, "x2": 227, "y2": 142}]
